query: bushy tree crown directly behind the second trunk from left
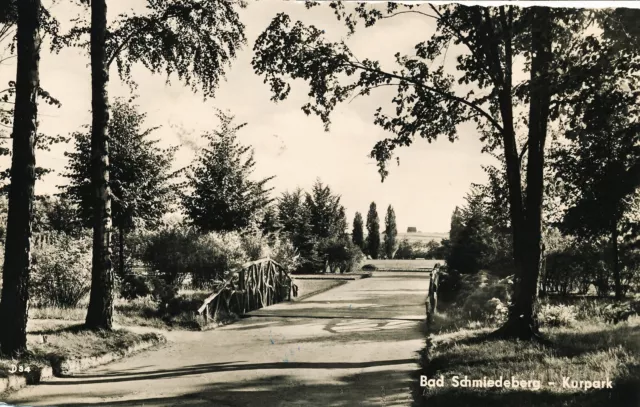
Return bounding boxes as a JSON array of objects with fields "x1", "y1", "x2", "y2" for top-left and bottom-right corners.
[{"x1": 63, "y1": 99, "x2": 176, "y2": 234}]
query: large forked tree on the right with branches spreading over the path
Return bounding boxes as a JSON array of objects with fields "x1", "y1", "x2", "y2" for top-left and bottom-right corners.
[{"x1": 252, "y1": 2, "x2": 640, "y2": 340}]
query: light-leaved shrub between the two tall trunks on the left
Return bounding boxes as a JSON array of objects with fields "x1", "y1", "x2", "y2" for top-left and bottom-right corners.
[{"x1": 30, "y1": 234, "x2": 91, "y2": 307}]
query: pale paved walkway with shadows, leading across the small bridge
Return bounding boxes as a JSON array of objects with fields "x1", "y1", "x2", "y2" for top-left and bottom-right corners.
[{"x1": 3, "y1": 272, "x2": 429, "y2": 407}]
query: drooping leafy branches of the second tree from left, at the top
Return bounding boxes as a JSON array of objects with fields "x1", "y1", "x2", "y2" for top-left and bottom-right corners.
[{"x1": 53, "y1": 0, "x2": 246, "y2": 97}]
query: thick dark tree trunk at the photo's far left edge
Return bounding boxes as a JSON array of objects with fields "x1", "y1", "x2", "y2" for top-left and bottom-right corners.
[{"x1": 0, "y1": 0, "x2": 41, "y2": 356}]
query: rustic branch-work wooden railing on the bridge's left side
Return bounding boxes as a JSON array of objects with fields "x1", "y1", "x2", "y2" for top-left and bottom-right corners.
[{"x1": 198, "y1": 258, "x2": 298, "y2": 322}]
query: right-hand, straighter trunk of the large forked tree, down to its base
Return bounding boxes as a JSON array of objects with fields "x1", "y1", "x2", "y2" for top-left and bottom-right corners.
[{"x1": 498, "y1": 7, "x2": 552, "y2": 340}]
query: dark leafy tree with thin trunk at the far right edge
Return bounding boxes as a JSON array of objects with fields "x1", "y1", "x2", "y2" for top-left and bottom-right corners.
[{"x1": 551, "y1": 71, "x2": 640, "y2": 298}]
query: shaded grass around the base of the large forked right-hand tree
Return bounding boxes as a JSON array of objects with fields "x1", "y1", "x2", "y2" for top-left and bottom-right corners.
[{"x1": 419, "y1": 315, "x2": 640, "y2": 407}]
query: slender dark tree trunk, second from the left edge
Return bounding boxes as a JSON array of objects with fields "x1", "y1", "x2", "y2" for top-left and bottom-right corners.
[{"x1": 86, "y1": 0, "x2": 113, "y2": 329}]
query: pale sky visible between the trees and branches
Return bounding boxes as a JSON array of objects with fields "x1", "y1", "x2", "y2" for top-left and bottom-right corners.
[{"x1": 0, "y1": 0, "x2": 636, "y2": 232}]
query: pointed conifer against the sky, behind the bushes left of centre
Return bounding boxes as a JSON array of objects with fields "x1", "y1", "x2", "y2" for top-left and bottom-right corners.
[{"x1": 182, "y1": 111, "x2": 273, "y2": 232}]
